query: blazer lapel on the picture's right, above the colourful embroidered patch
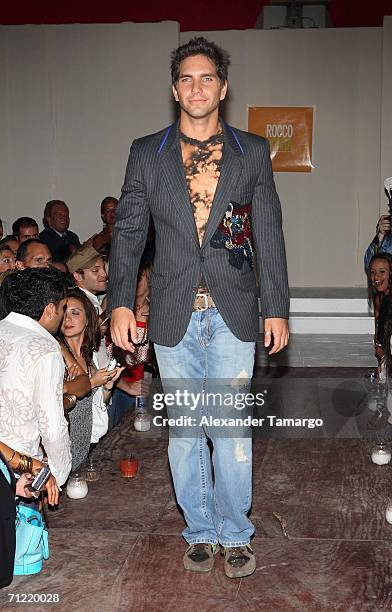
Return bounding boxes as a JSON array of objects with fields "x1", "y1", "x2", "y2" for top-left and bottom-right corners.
[{"x1": 201, "y1": 121, "x2": 242, "y2": 249}]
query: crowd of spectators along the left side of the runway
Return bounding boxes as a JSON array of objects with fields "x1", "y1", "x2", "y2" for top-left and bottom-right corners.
[{"x1": 0, "y1": 197, "x2": 153, "y2": 587}]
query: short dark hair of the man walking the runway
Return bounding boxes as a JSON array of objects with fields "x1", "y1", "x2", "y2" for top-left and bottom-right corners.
[{"x1": 170, "y1": 36, "x2": 230, "y2": 85}]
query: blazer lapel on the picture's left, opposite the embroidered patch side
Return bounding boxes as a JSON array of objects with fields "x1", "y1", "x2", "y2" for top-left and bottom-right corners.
[{"x1": 161, "y1": 122, "x2": 199, "y2": 247}]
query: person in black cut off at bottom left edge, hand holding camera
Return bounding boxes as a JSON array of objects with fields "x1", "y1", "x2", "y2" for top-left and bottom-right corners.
[{"x1": 0, "y1": 451, "x2": 41, "y2": 589}]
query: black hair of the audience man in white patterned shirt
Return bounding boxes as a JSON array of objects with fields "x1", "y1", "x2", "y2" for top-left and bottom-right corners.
[{"x1": 0, "y1": 268, "x2": 69, "y2": 321}]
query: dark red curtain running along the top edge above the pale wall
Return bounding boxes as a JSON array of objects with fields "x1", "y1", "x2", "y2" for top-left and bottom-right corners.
[{"x1": 0, "y1": 0, "x2": 392, "y2": 31}]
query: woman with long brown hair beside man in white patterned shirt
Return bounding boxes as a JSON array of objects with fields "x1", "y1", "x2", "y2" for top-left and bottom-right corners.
[{"x1": 59, "y1": 288, "x2": 123, "y2": 471}]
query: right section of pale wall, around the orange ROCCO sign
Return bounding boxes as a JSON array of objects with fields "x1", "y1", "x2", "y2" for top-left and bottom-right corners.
[{"x1": 181, "y1": 28, "x2": 382, "y2": 286}]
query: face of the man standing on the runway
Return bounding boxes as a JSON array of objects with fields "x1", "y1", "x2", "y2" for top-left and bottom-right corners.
[{"x1": 173, "y1": 55, "x2": 227, "y2": 119}]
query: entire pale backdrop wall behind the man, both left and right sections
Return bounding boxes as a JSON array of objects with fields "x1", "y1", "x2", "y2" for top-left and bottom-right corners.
[{"x1": 0, "y1": 18, "x2": 386, "y2": 286}]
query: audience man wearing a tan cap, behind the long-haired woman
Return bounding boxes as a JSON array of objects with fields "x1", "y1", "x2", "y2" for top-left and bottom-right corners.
[{"x1": 67, "y1": 245, "x2": 108, "y2": 314}]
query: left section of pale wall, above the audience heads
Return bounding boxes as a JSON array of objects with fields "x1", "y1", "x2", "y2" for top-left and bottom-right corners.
[{"x1": 0, "y1": 22, "x2": 178, "y2": 239}]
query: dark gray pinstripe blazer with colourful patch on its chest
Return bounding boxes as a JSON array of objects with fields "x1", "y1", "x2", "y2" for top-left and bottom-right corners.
[{"x1": 109, "y1": 121, "x2": 289, "y2": 346}]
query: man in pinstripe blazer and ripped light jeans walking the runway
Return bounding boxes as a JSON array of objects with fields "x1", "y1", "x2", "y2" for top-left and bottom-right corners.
[{"x1": 109, "y1": 38, "x2": 289, "y2": 578}]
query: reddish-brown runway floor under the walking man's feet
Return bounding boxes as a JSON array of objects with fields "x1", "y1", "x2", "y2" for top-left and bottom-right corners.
[{"x1": 0, "y1": 368, "x2": 392, "y2": 612}]
